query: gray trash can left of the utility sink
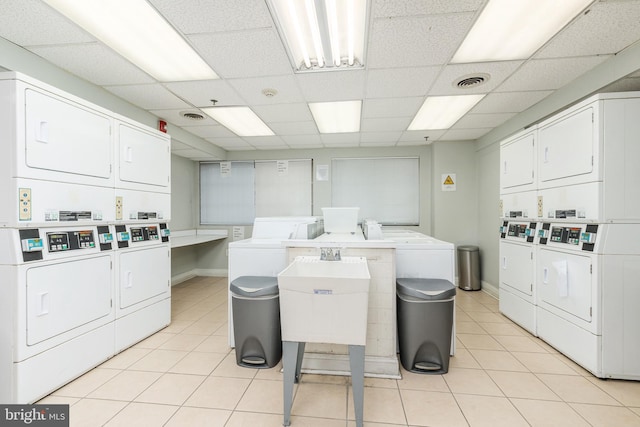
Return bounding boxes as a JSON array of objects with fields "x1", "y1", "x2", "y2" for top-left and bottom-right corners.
[{"x1": 230, "y1": 276, "x2": 282, "y2": 368}]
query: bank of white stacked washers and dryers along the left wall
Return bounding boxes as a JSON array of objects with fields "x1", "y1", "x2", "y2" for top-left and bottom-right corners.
[{"x1": 0, "y1": 73, "x2": 171, "y2": 403}]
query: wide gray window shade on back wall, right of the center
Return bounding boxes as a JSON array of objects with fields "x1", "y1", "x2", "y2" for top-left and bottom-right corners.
[{"x1": 331, "y1": 157, "x2": 420, "y2": 225}]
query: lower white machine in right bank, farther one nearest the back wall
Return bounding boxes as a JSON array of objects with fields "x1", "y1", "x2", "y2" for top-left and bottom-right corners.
[{"x1": 499, "y1": 222, "x2": 538, "y2": 335}]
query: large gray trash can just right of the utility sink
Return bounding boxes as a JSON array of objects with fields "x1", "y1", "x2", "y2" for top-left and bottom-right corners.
[{"x1": 396, "y1": 278, "x2": 456, "y2": 374}]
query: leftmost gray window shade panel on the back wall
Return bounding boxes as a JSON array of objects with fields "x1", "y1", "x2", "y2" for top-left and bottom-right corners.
[{"x1": 200, "y1": 162, "x2": 255, "y2": 225}]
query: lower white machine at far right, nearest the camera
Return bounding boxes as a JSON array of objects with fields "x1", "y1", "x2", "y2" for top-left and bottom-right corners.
[{"x1": 536, "y1": 222, "x2": 640, "y2": 380}]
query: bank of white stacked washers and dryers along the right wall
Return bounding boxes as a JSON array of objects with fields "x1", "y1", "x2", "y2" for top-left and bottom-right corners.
[{"x1": 500, "y1": 92, "x2": 640, "y2": 380}]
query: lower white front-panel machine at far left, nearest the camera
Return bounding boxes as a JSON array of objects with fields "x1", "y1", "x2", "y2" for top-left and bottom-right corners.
[{"x1": 0, "y1": 225, "x2": 115, "y2": 404}]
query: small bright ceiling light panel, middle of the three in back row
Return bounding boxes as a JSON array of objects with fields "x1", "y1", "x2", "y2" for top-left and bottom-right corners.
[{"x1": 309, "y1": 101, "x2": 362, "y2": 133}]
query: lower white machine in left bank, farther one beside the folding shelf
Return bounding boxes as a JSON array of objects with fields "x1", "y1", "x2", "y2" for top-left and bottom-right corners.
[{"x1": 114, "y1": 223, "x2": 171, "y2": 353}]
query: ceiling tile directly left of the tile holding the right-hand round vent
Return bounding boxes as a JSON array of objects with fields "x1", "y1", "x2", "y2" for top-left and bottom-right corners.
[{"x1": 366, "y1": 67, "x2": 442, "y2": 98}]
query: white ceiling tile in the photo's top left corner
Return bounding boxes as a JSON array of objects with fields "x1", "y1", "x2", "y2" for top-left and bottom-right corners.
[{"x1": 0, "y1": 0, "x2": 96, "y2": 46}]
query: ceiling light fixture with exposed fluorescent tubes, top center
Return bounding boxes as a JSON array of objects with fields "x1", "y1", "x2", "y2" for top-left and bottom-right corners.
[{"x1": 269, "y1": 0, "x2": 368, "y2": 71}]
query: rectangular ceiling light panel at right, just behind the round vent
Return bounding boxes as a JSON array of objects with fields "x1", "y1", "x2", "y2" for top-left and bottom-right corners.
[{"x1": 407, "y1": 94, "x2": 485, "y2": 130}]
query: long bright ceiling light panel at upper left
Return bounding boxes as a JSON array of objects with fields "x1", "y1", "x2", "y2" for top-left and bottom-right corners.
[{"x1": 44, "y1": 0, "x2": 218, "y2": 82}]
